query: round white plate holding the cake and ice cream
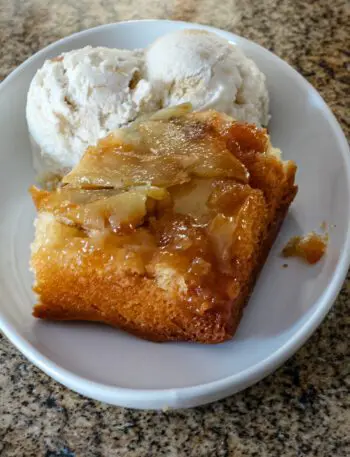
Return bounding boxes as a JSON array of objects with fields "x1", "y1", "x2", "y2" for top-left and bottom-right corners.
[{"x1": 0, "y1": 21, "x2": 350, "y2": 408}]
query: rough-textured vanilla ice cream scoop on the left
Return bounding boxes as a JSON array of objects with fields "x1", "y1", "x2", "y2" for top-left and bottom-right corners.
[{"x1": 26, "y1": 46, "x2": 159, "y2": 181}]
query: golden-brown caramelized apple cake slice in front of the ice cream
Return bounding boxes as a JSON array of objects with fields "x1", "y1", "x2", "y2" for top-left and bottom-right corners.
[{"x1": 31, "y1": 106, "x2": 297, "y2": 343}]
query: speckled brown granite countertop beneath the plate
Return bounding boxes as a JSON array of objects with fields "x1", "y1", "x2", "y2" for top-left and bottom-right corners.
[{"x1": 0, "y1": 0, "x2": 350, "y2": 457}]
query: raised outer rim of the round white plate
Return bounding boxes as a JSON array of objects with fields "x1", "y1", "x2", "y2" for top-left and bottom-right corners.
[{"x1": 0, "y1": 19, "x2": 350, "y2": 409}]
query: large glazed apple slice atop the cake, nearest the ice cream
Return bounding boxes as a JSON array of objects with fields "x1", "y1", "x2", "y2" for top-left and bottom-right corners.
[{"x1": 63, "y1": 106, "x2": 249, "y2": 188}]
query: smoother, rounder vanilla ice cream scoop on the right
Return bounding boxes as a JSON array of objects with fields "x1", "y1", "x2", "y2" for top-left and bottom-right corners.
[{"x1": 145, "y1": 29, "x2": 269, "y2": 126}]
